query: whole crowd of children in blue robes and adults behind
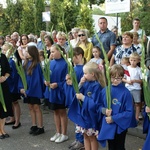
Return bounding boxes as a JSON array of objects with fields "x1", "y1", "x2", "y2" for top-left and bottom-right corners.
[{"x1": 0, "y1": 17, "x2": 150, "y2": 150}]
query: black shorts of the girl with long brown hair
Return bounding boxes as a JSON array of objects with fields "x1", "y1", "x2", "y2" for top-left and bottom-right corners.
[{"x1": 24, "y1": 97, "x2": 41, "y2": 105}]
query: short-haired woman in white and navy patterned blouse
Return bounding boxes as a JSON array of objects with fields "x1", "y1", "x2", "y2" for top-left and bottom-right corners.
[{"x1": 110, "y1": 31, "x2": 136, "y2": 65}]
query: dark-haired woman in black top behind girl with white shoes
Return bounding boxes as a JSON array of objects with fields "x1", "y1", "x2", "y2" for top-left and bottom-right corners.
[{"x1": 44, "y1": 35, "x2": 54, "y2": 58}]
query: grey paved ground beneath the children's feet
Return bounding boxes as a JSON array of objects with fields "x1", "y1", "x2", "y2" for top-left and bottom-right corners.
[{"x1": 0, "y1": 101, "x2": 144, "y2": 150}]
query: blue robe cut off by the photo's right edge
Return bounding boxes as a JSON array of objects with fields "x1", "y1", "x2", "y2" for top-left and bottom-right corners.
[{"x1": 142, "y1": 109, "x2": 150, "y2": 150}]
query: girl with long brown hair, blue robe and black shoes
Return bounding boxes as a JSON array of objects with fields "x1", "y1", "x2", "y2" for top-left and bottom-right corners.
[{"x1": 19, "y1": 45, "x2": 44, "y2": 135}]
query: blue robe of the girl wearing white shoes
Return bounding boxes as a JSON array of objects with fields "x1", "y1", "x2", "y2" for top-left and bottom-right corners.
[{"x1": 49, "y1": 58, "x2": 67, "y2": 104}]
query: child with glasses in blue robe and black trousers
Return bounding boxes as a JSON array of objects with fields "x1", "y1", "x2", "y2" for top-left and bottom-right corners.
[{"x1": 98, "y1": 65, "x2": 136, "y2": 150}]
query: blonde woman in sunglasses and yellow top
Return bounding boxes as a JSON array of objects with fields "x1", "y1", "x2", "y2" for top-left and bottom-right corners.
[{"x1": 77, "y1": 29, "x2": 93, "y2": 62}]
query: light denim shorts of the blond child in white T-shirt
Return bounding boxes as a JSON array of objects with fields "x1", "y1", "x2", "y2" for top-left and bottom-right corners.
[{"x1": 130, "y1": 90, "x2": 141, "y2": 103}]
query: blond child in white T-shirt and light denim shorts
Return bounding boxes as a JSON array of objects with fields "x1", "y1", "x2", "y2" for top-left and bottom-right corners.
[{"x1": 123, "y1": 53, "x2": 142, "y2": 121}]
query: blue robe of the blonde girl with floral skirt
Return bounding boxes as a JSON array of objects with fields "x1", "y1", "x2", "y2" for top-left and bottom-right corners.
[{"x1": 68, "y1": 81, "x2": 102, "y2": 130}]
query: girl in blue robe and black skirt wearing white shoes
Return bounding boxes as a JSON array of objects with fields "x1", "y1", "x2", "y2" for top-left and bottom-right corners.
[{"x1": 46, "y1": 44, "x2": 68, "y2": 143}]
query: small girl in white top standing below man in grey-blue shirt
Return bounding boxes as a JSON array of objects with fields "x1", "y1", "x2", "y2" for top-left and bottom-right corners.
[{"x1": 90, "y1": 46, "x2": 103, "y2": 64}]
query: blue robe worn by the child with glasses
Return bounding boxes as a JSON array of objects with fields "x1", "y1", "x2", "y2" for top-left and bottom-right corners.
[{"x1": 98, "y1": 83, "x2": 137, "y2": 147}]
